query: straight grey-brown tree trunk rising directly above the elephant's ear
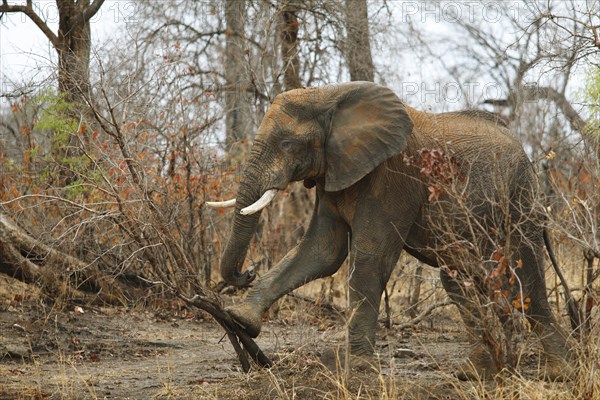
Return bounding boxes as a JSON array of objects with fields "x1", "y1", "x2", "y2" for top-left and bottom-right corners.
[{"x1": 346, "y1": 0, "x2": 375, "y2": 81}]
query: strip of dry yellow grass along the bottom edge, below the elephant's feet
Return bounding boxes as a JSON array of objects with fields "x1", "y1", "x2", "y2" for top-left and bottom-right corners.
[{"x1": 190, "y1": 340, "x2": 600, "y2": 400}]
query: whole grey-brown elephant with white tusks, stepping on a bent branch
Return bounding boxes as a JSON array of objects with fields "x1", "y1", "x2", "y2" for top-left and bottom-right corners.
[{"x1": 211, "y1": 82, "x2": 569, "y2": 378}]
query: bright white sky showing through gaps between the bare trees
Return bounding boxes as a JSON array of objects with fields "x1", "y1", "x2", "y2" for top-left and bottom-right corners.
[{"x1": 0, "y1": 0, "x2": 581, "y2": 108}]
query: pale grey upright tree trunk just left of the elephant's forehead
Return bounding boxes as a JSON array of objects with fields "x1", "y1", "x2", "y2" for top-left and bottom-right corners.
[{"x1": 225, "y1": 0, "x2": 251, "y2": 163}]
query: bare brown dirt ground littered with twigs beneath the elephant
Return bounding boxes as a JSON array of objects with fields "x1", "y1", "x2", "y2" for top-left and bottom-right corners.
[{"x1": 0, "y1": 278, "x2": 572, "y2": 399}]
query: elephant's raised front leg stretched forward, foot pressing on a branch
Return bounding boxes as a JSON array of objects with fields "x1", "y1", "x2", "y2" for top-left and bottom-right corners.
[{"x1": 228, "y1": 197, "x2": 349, "y2": 337}]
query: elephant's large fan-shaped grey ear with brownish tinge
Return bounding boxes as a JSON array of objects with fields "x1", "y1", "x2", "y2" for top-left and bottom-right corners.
[{"x1": 325, "y1": 82, "x2": 413, "y2": 192}]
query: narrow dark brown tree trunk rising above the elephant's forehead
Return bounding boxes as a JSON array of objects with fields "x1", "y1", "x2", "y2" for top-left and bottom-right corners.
[{"x1": 279, "y1": 0, "x2": 302, "y2": 90}]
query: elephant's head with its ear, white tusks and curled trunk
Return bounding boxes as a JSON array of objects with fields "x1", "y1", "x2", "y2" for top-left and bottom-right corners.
[{"x1": 212, "y1": 82, "x2": 413, "y2": 286}]
